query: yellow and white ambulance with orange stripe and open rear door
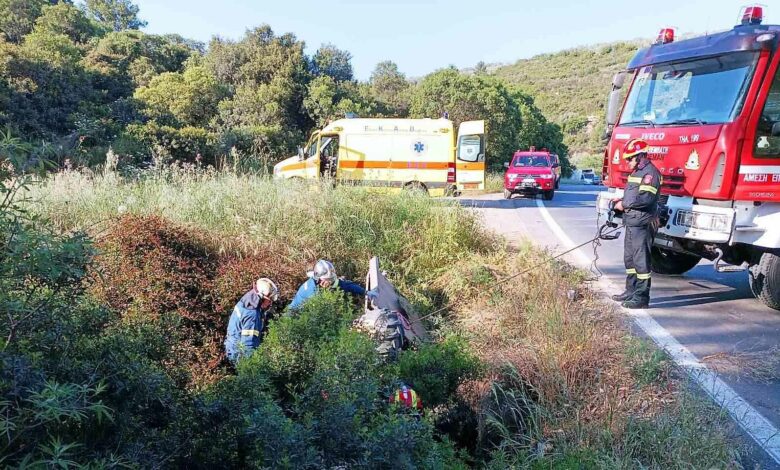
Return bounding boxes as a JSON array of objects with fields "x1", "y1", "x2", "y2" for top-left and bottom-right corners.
[{"x1": 274, "y1": 118, "x2": 485, "y2": 196}]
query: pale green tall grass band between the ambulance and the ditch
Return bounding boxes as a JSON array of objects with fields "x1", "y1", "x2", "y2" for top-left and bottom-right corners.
[{"x1": 29, "y1": 169, "x2": 496, "y2": 288}]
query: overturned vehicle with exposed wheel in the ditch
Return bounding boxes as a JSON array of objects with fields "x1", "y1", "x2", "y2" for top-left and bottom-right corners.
[{"x1": 355, "y1": 257, "x2": 430, "y2": 360}]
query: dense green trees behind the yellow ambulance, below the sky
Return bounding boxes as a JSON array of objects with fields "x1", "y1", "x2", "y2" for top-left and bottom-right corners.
[{"x1": 0, "y1": 0, "x2": 566, "y2": 167}]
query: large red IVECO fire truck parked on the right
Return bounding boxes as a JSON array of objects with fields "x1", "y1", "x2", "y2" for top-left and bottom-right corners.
[{"x1": 597, "y1": 6, "x2": 780, "y2": 309}]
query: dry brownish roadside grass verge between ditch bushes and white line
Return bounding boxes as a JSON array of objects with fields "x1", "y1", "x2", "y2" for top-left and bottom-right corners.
[{"x1": 438, "y1": 245, "x2": 735, "y2": 468}]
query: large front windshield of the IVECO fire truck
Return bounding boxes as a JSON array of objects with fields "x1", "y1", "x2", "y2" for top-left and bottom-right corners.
[{"x1": 619, "y1": 52, "x2": 758, "y2": 127}]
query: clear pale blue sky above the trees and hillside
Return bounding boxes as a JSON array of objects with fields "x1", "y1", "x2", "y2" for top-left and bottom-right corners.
[{"x1": 135, "y1": 0, "x2": 780, "y2": 80}]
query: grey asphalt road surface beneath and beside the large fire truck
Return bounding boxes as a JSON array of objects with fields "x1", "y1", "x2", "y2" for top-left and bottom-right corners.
[{"x1": 459, "y1": 185, "x2": 780, "y2": 468}]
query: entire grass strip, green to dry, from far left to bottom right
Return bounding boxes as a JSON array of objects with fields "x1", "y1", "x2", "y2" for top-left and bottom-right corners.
[{"x1": 28, "y1": 165, "x2": 734, "y2": 469}]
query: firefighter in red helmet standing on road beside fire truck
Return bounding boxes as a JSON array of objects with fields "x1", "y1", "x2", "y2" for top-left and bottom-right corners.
[{"x1": 612, "y1": 139, "x2": 661, "y2": 309}]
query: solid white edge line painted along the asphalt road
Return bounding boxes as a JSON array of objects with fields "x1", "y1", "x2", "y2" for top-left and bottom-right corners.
[{"x1": 536, "y1": 199, "x2": 780, "y2": 464}]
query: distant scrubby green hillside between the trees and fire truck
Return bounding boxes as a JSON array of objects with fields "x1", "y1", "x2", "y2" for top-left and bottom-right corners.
[{"x1": 493, "y1": 40, "x2": 648, "y2": 153}]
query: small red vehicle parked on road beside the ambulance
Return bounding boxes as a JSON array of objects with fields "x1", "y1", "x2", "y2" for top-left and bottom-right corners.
[{"x1": 504, "y1": 150, "x2": 559, "y2": 201}]
